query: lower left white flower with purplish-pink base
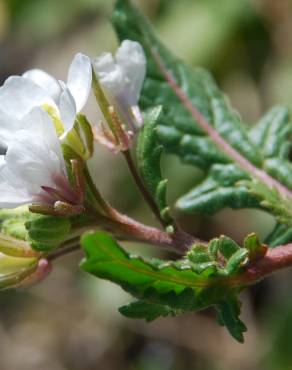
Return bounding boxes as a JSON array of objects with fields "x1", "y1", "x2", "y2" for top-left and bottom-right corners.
[{"x1": 0, "y1": 107, "x2": 74, "y2": 208}]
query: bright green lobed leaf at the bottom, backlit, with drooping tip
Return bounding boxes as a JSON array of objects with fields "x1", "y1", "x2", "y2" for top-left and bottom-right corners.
[{"x1": 81, "y1": 231, "x2": 266, "y2": 341}]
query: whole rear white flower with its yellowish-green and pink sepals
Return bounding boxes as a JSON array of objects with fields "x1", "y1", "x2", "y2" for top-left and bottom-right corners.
[{"x1": 93, "y1": 40, "x2": 146, "y2": 152}]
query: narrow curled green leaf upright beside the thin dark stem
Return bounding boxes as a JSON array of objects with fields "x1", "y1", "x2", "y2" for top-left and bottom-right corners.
[{"x1": 137, "y1": 106, "x2": 171, "y2": 222}]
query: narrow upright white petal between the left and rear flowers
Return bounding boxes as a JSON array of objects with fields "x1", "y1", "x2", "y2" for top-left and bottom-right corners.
[{"x1": 67, "y1": 53, "x2": 92, "y2": 112}]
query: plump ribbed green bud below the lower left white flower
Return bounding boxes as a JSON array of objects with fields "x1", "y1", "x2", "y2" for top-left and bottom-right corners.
[{"x1": 25, "y1": 215, "x2": 71, "y2": 252}]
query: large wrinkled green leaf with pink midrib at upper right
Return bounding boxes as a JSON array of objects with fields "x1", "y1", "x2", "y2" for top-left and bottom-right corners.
[{"x1": 112, "y1": 0, "x2": 292, "y2": 231}]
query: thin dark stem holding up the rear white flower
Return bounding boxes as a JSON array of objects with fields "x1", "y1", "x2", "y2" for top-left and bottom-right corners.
[{"x1": 123, "y1": 150, "x2": 167, "y2": 227}]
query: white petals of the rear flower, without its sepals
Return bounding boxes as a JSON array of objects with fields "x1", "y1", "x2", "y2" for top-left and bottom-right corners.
[{"x1": 93, "y1": 40, "x2": 146, "y2": 130}]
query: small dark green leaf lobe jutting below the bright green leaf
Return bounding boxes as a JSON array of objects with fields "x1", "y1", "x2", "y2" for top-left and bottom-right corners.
[{"x1": 119, "y1": 301, "x2": 177, "y2": 322}]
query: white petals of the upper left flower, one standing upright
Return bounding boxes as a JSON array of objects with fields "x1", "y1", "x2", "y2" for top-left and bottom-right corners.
[{"x1": 0, "y1": 53, "x2": 92, "y2": 145}]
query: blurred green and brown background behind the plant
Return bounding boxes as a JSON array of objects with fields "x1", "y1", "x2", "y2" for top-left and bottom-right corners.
[{"x1": 0, "y1": 0, "x2": 292, "y2": 370}]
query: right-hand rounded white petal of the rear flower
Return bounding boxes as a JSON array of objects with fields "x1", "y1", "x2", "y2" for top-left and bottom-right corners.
[{"x1": 116, "y1": 40, "x2": 146, "y2": 105}]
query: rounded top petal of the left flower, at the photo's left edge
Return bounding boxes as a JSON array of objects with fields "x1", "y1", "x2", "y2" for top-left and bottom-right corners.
[{"x1": 0, "y1": 76, "x2": 57, "y2": 119}]
